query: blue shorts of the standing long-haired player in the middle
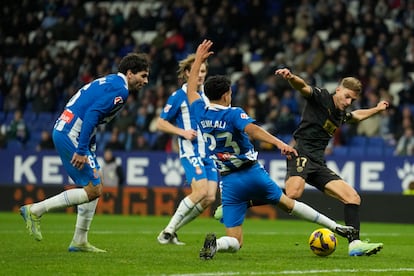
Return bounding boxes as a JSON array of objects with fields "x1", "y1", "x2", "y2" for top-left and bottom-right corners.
[{"x1": 181, "y1": 156, "x2": 218, "y2": 184}]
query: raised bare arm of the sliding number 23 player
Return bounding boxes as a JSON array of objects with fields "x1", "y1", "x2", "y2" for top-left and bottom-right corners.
[{"x1": 187, "y1": 39, "x2": 213, "y2": 105}]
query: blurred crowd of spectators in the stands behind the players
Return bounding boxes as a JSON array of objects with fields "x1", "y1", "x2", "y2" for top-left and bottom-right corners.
[{"x1": 0, "y1": 0, "x2": 414, "y2": 155}]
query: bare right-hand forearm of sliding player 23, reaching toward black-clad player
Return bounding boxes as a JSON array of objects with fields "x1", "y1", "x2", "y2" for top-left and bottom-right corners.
[{"x1": 244, "y1": 123, "x2": 298, "y2": 158}]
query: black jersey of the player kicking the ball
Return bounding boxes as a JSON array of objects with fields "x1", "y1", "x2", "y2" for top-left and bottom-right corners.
[{"x1": 293, "y1": 87, "x2": 346, "y2": 163}]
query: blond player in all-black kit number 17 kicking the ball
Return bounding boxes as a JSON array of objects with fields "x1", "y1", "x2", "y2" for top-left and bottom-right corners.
[{"x1": 275, "y1": 68, "x2": 389, "y2": 256}]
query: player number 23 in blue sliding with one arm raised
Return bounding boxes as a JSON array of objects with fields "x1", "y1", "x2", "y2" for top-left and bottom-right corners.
[{"x1": 187, "y1": 40, "x2": 355, "y2": 260}]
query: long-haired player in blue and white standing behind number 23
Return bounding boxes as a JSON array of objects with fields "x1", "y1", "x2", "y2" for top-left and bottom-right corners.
[{"x1": 157, "y1": 54, "x2": 218, "y2": 245}]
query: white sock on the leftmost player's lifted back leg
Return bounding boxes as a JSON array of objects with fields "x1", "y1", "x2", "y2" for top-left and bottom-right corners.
[{"x1": 30, "y1": 188, "x2": 89, "y2": 217}]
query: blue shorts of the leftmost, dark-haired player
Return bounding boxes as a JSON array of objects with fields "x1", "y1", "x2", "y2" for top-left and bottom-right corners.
[{"x1": 52, "y1": 129, "x2": 101, "y2": 186}]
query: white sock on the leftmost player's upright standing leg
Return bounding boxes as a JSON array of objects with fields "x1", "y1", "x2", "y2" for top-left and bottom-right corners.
[{"x1": 73, "y1": 198, "x2": 98, "y2": 244}]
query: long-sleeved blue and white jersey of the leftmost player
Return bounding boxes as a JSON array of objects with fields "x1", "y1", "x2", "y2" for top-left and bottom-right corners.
[{"x1": 54, "y1": 73, "x2": 129, "y2": 155}]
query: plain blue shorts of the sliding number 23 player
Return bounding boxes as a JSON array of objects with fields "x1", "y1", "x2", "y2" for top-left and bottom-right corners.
[{"x1": 220, "y1": 163, "x2": 282, "y2": 228}]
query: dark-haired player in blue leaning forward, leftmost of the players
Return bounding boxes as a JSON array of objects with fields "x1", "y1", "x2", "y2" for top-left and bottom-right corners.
[{"x1": 20, "y1": 53, "x2": 149, "y2": 252}]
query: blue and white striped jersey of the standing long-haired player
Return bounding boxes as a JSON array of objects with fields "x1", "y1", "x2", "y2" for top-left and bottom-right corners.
[{"x1": 160, "y1": 84, "x2": 208, "y2": 158}]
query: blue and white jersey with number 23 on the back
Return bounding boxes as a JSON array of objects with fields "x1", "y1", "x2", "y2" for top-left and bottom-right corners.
[{"x1": 191, "y1": 99, "x2": 257, "y2": 173}]
